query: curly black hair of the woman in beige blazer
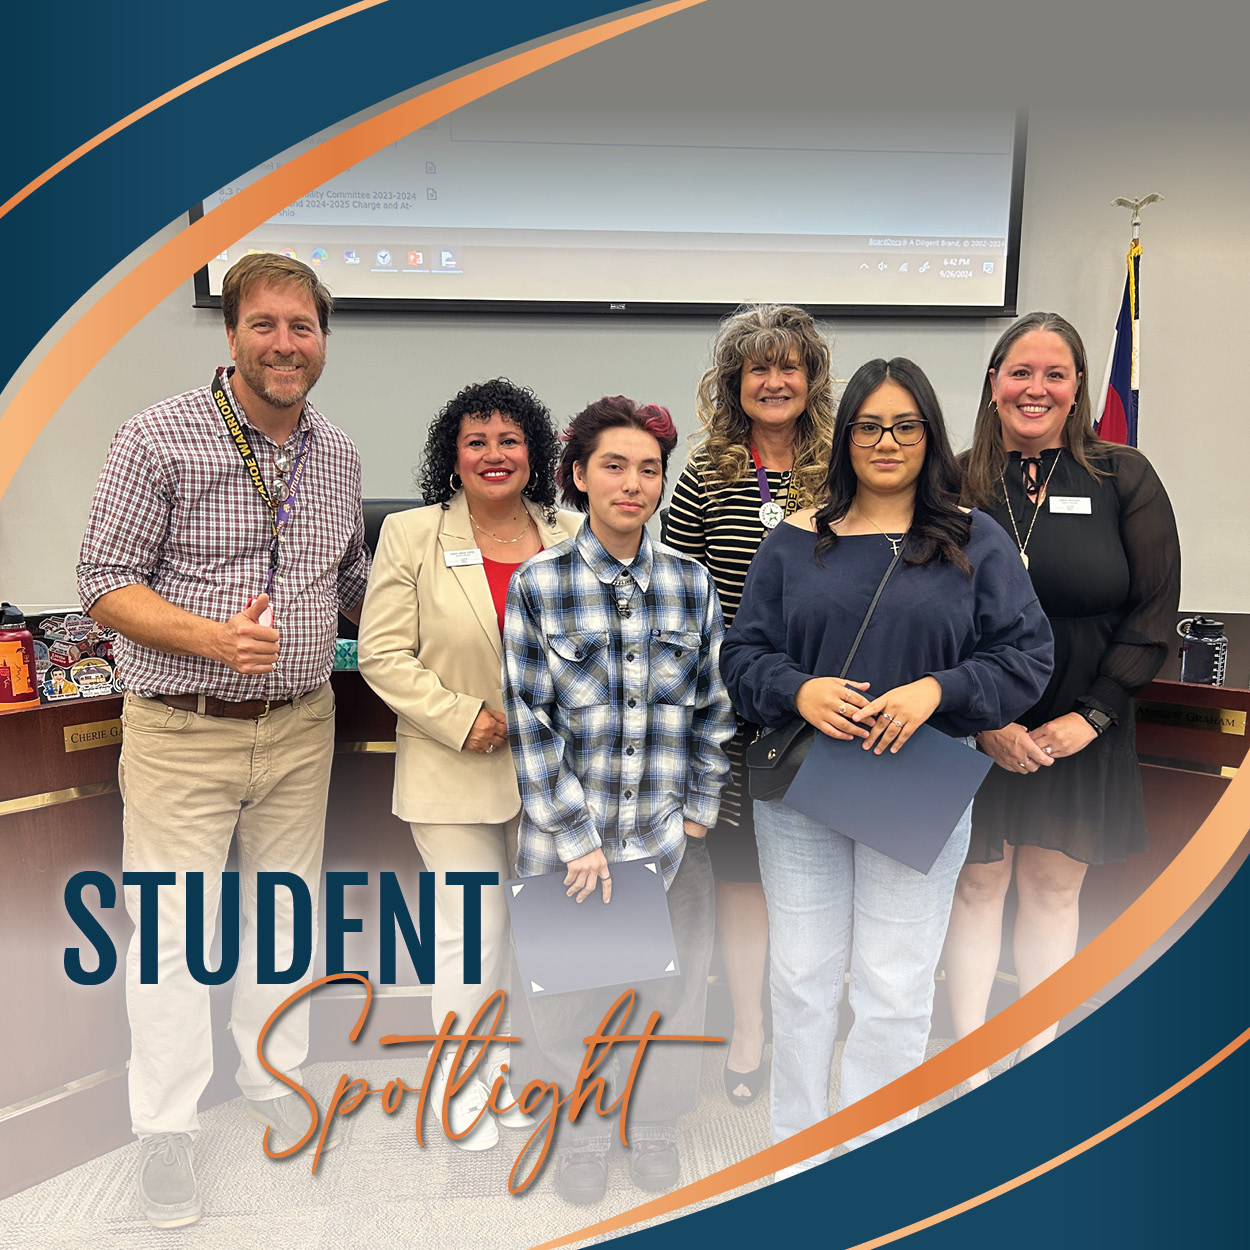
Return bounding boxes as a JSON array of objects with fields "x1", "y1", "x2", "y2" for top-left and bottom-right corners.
[{"x1": 418, "y1": 378, "x2": 560, "y2": 524}]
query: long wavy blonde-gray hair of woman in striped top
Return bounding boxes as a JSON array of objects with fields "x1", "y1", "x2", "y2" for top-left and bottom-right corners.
[{"x1": 696, "y1": 304, "x2": 834, "y2": 508}]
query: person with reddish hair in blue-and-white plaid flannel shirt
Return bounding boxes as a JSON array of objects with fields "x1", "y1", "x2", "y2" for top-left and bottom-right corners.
[{"x1": 504, "y1": 396, "x2": 735, "y2": 1203}]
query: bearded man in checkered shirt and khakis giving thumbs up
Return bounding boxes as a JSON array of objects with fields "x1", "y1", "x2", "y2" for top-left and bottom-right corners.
[{"x1": 79, "y1": 254, "x2": 369, "y2": 1228}]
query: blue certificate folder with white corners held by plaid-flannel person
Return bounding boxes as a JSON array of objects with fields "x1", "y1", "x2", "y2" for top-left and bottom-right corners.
[{"x1": 504, "y1": 859, "x2": 681, "y2": 999}]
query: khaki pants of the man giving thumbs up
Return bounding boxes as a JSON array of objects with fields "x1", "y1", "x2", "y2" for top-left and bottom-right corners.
[{"x1": 119, "y1": 683, "x2": 334, "y2": 1136}]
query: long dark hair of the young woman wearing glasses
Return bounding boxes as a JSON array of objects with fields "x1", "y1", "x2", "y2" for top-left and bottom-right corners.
[{"x1": 815, "y1": 356, "x2": 973, "y2": 573}]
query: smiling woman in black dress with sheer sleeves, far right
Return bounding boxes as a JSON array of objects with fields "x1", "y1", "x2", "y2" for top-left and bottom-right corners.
[{"x1": 946, "y1": 313, "x2": 1180, "y2": 1088}]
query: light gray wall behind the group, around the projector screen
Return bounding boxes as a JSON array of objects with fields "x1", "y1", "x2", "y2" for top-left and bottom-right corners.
[{"x1": 0, "y1": 100, "x2": 1250, "y2": 614}]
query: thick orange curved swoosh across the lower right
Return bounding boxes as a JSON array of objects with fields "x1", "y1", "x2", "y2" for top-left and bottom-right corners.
[{"x1": 534, "y1": 766, "x2": 1250, "y2": 1250}]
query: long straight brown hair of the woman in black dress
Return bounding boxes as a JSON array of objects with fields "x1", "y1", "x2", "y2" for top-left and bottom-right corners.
[{"x1": 960, "y1": 313, "x2": 1114, "y2": 508}]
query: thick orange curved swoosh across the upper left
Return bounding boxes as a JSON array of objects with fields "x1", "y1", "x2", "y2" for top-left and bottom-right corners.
[{"x1": 0, "y1": 0, "x2": 704, "y2": 494}]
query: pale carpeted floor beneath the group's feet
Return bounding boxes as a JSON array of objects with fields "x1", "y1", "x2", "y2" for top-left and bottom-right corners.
[{"x1": 0, "y1": 1041, "x2": 975, "y2": 1250}]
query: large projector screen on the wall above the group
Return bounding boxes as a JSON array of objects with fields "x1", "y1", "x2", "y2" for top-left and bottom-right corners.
[{"x1": 191, "y1": 106, "x2": 1025, "y2": 316}]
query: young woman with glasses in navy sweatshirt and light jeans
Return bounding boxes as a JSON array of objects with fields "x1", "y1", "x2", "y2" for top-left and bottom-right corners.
[{"x1": 721, "y1": 358, "x2": 1054, "y2": 1166}]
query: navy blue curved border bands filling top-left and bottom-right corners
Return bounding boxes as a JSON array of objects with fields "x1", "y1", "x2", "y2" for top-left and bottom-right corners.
[{"x1": 0, "y1": 0, "x2": 1250, "y2": 1250}]
